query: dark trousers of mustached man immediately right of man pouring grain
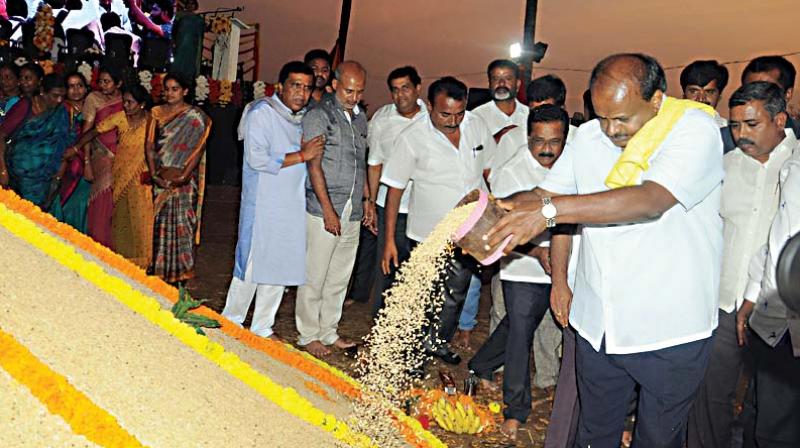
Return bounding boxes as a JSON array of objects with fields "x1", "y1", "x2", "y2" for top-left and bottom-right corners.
[{"x1": 686, "y1": 310, "x2": 747, "y2": 448}]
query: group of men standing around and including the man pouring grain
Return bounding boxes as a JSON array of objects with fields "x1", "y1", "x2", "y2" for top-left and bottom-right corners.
[{"x1": 223, "y1": 50, "x2": 800, "y2": 448}]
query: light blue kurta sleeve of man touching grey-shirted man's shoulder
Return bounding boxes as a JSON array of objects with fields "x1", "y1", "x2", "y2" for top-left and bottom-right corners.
[{"x1": 244, "y1": 108, "x2": 285, "y2": 174}]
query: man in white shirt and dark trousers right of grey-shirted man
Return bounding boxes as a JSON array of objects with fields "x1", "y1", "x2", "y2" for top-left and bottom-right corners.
[{"x1": 367, "y1": 66, "x2": 428, "y2": 314}]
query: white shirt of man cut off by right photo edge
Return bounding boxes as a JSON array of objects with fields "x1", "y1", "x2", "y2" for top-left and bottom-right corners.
[{"x1": 744, "y1": 145, "x2": 800, "y2": 346}]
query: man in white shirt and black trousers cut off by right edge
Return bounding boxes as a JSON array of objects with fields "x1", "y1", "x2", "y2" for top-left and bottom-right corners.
[{"x1": 731, "y1": 86, "x2": 800, "y2": 448}]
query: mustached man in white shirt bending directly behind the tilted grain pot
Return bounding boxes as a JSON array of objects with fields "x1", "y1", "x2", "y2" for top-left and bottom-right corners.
[{"x1": 469, "y1": 104, "x2": 577, "y2": 440}]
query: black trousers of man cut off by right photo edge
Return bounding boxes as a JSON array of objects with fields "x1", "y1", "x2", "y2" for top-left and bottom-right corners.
[{"x1": 747, "y1": 331, "x2": 800, "y2": 448}]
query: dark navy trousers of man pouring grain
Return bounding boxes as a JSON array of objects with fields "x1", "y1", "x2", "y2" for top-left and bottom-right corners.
[{"x1": 575, "y1": 334, "x2": 713, "y2": 448}]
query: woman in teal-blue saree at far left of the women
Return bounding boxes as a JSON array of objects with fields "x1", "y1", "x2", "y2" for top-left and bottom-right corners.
[{"x1": 0, "y1": 74, "x2": 74, "y2": 206}]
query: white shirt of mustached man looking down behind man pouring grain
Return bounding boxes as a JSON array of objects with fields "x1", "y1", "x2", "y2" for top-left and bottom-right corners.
[{"x1": 719, "y1": 129, "x2": 798, "y2": 313}]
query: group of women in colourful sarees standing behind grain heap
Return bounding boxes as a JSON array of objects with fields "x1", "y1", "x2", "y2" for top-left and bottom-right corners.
[{"x1": 0, "y1": 63, "x2": 211, "y2": 283}]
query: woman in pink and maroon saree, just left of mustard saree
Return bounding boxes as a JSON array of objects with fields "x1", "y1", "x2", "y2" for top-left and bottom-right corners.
[{"x1": 83, "y1": 67, "x2": 122, "y2": 249}]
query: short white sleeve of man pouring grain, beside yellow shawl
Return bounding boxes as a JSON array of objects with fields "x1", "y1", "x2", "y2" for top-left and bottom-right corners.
[{"x1": 642, "y1": 110, "x2": 724, "y2": 210}]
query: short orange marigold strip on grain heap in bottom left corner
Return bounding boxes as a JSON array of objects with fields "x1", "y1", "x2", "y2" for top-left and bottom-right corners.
[{"x1": 0, "y1": 329, "x2": 144, "y2": 447}]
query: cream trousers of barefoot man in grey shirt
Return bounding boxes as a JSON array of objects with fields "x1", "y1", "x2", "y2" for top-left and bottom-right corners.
[{"x1": 295, "y1": 201, "x2": 361, "y2": 345}]
